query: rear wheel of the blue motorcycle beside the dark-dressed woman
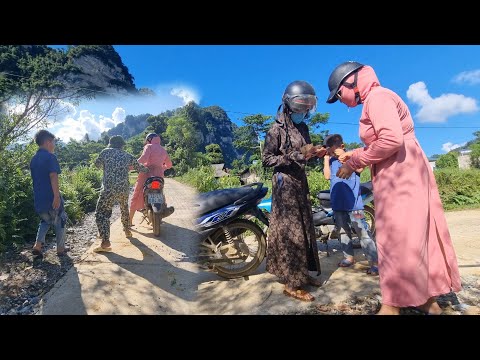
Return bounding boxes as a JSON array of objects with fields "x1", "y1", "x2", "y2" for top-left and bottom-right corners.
[{"x1": 206, "y1": 219, "x2": 267, "y2": 279}]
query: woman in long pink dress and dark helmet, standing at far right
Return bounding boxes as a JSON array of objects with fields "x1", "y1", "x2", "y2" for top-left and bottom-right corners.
[{"x1": 327, "y1": 61, "x2": 461, "y2": 315}]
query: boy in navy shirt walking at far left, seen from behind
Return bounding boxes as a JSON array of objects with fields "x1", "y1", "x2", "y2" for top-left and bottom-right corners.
[{"x1": 30, "y1": 130, "x2": 67, "y2": 255}]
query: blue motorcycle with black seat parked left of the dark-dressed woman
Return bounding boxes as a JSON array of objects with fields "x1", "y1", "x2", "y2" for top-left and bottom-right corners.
[{"x1": 195, "y1": 183, "x2": 268, "y2": 279}]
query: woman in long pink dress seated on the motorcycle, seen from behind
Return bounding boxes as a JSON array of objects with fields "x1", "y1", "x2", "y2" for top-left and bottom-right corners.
[{"x1": 130, "y1": 136, "x2": 172, "y2": 210}]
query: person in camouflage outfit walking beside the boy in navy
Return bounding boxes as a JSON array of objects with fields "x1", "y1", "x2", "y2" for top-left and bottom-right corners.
[{"x1": 95, "y1": 135, "x2": 148, "y2": 251}]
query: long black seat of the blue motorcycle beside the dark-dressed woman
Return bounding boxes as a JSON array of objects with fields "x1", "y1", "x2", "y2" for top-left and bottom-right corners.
[{"x1": 195, "y1": 187, "x2": 258, "y2": 214}]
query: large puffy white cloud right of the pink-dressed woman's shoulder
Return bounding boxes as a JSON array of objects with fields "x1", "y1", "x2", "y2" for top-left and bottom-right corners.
[{"x1": 407, "y1": 81, "x2": 478, "y2": 122}]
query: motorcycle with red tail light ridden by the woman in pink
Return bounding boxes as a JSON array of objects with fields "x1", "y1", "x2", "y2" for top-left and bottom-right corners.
[{"x1": 141, "y1": 176, "x2": 175, "y2": 236}]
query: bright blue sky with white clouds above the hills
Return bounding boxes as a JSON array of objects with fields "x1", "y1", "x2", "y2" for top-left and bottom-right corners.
[{"x1": 46, "y1": 45, "x2": 480, "y2": 156}]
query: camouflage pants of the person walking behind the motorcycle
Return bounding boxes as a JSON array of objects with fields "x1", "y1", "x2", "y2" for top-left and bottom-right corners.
[{"x1": 95, "y1": 190, "x2": 129, "y2": 241}]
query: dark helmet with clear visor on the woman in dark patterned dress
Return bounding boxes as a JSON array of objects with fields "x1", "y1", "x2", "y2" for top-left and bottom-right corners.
[{"x1": 282, "y1": 80, "x2": 317, "y2": 113}]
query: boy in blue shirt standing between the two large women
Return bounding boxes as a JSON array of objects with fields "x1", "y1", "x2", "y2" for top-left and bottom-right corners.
[{"x1": 323, "y1": 134, "x2": 378, "y2": 275}]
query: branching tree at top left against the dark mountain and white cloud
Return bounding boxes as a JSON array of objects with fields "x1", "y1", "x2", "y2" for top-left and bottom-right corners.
[{"x1": 0, "y1": 45, "x2": 94, "y2": 151}]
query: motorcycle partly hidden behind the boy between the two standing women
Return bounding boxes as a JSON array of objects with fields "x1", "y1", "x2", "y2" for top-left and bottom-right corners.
[{"x1": 258, "y1": 181, "x2": 375, "y2": 256}]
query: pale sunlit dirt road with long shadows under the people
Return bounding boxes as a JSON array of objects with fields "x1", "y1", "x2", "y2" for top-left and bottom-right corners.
[{"x1": 39, "y1": 178, "x2": 480, "y2": 314}]
